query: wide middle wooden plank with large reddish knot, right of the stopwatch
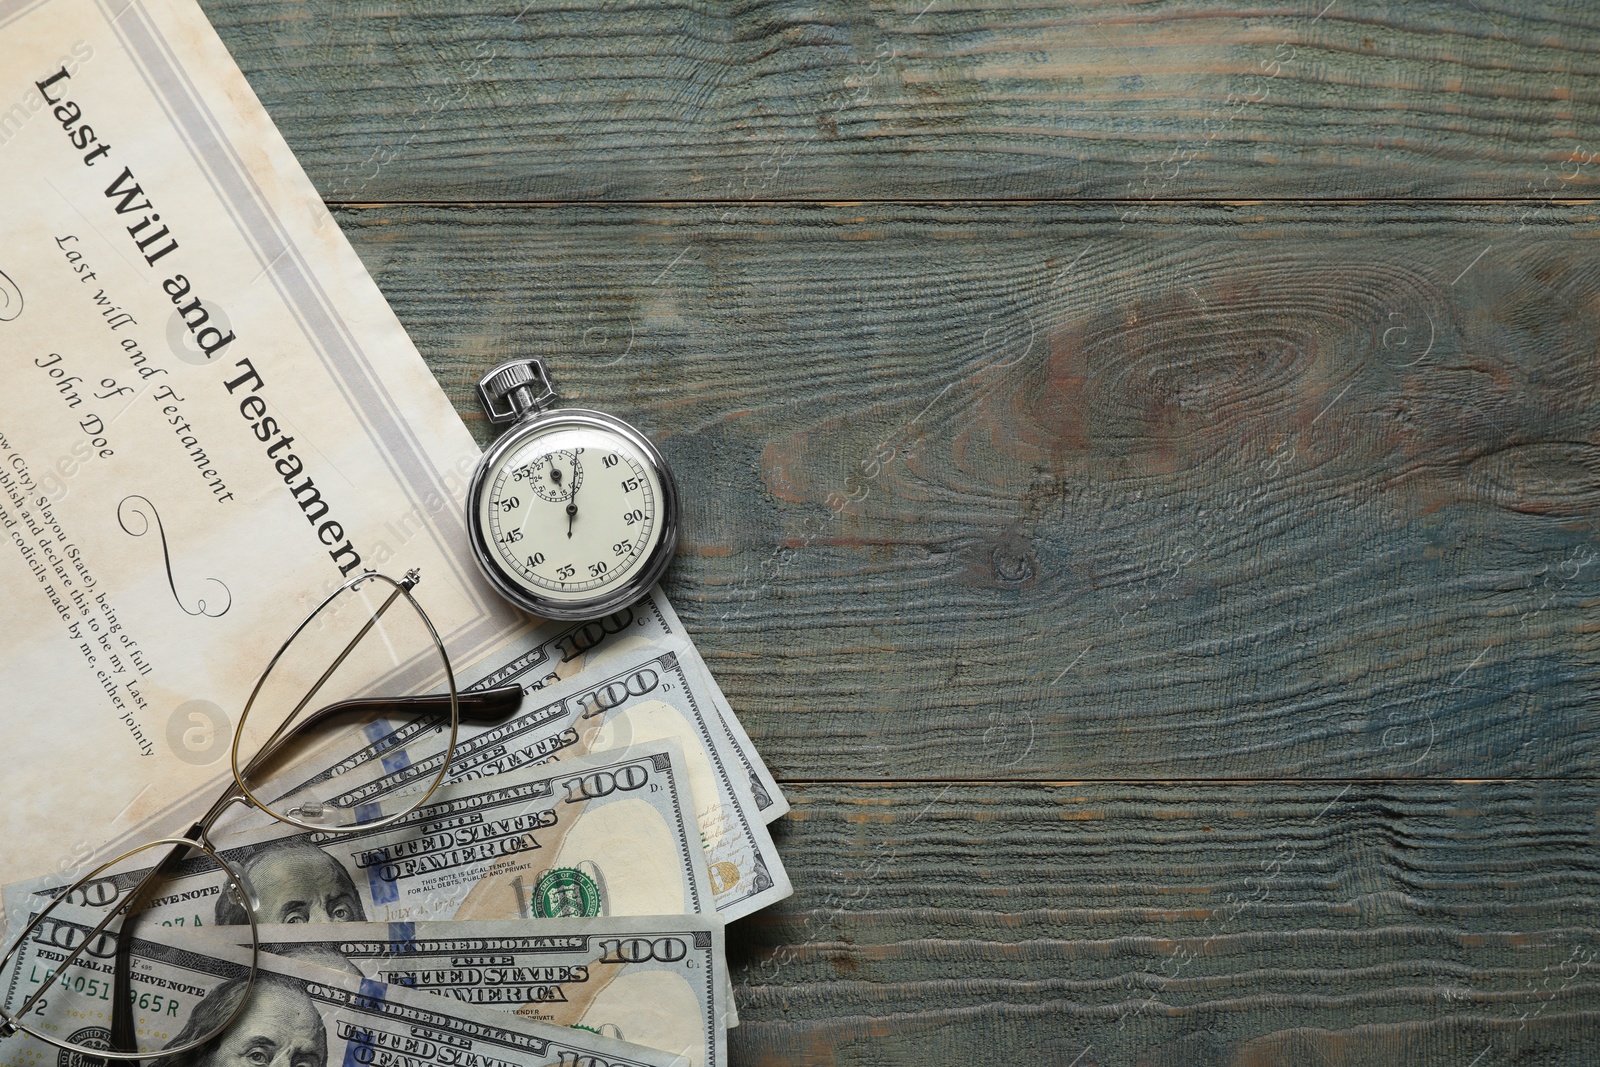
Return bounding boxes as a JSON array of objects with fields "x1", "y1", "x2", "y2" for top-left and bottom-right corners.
[{"x1": 339, "y1": 203, "x2": 1600, "y2": 781}]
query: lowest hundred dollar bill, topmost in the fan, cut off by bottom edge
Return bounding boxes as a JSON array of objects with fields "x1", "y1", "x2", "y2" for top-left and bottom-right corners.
[{"x1": 0, "y1": 905, "x2": 683, "y2": 1067}]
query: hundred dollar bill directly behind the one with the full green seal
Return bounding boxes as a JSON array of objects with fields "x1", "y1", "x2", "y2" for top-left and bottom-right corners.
[{"x1": 275, "y1": 638, "x2": 794, "y2": 921}]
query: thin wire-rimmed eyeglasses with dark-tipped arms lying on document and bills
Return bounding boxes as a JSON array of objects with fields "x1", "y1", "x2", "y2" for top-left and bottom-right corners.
[{"x1": 0, "y1": 571, "x2": 522, "y2": 1061}]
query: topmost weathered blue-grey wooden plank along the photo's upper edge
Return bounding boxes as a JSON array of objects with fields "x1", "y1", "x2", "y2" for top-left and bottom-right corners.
[{"x1": 196, "y1": 0, "x2": 1600, "y2": 210}]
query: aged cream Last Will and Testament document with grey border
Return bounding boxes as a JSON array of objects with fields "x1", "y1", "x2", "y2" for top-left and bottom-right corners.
[{"x1": 0, "y1": 0, "x2": 526, "y2": 881}]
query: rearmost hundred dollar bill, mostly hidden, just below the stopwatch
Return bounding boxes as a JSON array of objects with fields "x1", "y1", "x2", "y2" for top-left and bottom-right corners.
[{"x1": 462, "y1": 585, "x2": 789, "y2": 822}]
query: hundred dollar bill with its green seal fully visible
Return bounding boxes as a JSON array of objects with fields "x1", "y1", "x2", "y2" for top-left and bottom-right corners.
[{"x1": 5, "y1": 739, "x2": 714, "y2": 929}]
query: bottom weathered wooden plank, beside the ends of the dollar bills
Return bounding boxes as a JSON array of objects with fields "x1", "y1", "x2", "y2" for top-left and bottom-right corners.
[{"x1": 730, "y1": 781, "x2": 1600, "y2": 1067}]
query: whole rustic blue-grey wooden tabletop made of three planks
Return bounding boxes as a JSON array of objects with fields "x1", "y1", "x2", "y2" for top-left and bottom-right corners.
[{"x1": 205, "y1": 0, "x2": 1600, "y2": 1067}]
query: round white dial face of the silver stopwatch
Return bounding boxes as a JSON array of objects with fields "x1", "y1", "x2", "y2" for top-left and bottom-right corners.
[{"x1": 478, "y1": 422, "x2": 664, "y2": 601}]
